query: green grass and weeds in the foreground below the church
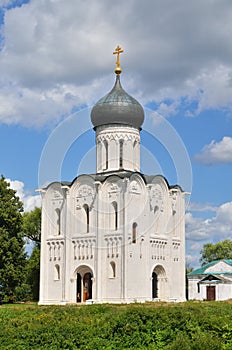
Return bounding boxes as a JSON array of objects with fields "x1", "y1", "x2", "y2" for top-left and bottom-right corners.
[{"x1": 0, "y1": 302, "x2": 232, "y2": 350}]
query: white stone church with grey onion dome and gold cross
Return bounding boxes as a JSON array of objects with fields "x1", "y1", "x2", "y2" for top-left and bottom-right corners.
[{"x1": 39, "y1": 46, "x2": 185, "y2": 305}]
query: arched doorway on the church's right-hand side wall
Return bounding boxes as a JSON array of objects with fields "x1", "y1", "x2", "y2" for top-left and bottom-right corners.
[{"x1": 152, "y1": 265, "x2": 167, "y2": 299}]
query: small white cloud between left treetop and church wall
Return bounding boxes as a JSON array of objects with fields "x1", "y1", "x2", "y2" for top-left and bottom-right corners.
[{"x1": 6, "y1": 179, "x2": 41, "y2": 211}]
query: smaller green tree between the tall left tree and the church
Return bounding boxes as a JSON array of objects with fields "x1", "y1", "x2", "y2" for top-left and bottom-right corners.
[{"x1": 22, "y1": 207, "x2": 41, "y2": 246}]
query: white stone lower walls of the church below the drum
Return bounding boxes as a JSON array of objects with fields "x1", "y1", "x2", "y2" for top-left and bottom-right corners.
[{"x1": 40, "y1": 174, "x2": 186, "y2": 304}]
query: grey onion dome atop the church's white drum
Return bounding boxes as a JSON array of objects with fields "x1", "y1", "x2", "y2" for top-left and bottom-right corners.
[{"x1": 91, "y1": 75, "x2": 144, "y2": 129}]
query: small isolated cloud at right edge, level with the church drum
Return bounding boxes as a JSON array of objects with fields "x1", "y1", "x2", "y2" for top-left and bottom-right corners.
[{"x1": 195, "y1": 136, "x2": 232, "y2": 165}]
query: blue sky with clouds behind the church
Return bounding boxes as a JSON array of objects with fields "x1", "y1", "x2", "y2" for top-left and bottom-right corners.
[{"x1": 0, "y1": 0, "x2": 232, "y2": 267}]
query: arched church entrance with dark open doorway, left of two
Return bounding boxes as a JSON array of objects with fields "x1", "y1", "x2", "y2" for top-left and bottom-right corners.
[{"x1": 76, "y1": 266, "x2": 93, "y2": 303}]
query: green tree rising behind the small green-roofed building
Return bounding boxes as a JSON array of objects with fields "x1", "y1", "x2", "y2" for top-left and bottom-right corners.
[{"x1": 200, "y1": 239, "x2": 232, "y2": 265}]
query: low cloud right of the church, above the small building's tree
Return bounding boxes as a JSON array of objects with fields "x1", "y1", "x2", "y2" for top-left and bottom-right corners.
[{"x1": 185, "y1": 202, "x2": 232, "y2": 267}]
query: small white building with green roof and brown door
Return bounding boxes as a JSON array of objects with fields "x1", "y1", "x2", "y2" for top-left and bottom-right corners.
[{"x1": 187, "y1": 259, "x2": 232, "y2": 300}]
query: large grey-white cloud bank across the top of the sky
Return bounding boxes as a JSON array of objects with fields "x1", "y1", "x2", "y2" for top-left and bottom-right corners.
[{"x1": 0, "y1": 0, "x2": 232, "y2": 127}]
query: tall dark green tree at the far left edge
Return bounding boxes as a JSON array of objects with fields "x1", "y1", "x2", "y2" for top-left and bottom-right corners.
[{"x1": 0, "y1": 176, "x2": 26, "y2": 296}]
